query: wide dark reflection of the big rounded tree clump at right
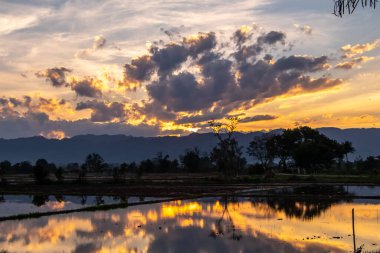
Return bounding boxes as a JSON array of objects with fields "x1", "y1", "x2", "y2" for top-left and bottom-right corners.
[{"x1": 251, "y1": 186, "x2": 353, "y2": 221}]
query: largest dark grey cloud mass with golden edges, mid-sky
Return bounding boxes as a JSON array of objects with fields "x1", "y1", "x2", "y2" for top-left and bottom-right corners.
[{"x1": 120, "y1": 27, "x2": 343, "y2": 124}]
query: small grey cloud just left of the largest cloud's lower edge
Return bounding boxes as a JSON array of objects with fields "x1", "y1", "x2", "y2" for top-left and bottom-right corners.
[{"x1": 76, "y1": 100, "x2": 127, "y2": 122}]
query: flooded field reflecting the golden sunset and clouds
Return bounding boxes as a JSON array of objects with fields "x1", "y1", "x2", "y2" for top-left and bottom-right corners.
[{"x1": 0, "y1": 186, "x2": 380, "y2": 253}]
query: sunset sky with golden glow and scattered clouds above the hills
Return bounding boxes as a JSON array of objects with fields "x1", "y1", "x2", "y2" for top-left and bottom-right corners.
[{"x1": 0, "y1": 0, "x2": 380, "y2": 138}]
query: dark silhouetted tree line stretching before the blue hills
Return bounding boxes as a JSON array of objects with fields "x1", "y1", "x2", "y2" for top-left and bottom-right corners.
[{"x1": 0, "y1": 120, "x2": 380, "y2": 183}]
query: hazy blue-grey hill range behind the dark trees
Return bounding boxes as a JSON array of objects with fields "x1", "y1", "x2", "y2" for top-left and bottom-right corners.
[{"x1": 0, "y1": 128, "x2": 380, "y2": 164}]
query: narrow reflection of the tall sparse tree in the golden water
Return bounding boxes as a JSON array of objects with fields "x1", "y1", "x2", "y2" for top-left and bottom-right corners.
[{"x1": 210, "y1": 196, "x2": 243, "y2": 241}]
